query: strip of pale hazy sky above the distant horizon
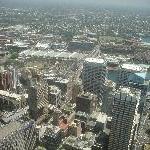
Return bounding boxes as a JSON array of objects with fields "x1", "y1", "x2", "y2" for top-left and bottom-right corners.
[{"x1": 0, "y1": 0, "x2": 150, "y2": 8}]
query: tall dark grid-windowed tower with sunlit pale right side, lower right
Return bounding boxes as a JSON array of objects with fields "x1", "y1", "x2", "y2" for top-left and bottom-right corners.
[{"x1": 108, "y1": 88, "x2": 140, "y2": 150}]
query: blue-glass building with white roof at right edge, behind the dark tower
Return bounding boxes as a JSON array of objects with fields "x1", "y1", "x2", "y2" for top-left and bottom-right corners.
[{"x1": 117, "y1": 64, "x2": 150, "y2": 112}]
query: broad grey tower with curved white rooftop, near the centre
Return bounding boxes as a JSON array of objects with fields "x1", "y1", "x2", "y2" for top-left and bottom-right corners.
[{"x1": 82, "y1": 58, "x2": 106, "y2": 99}]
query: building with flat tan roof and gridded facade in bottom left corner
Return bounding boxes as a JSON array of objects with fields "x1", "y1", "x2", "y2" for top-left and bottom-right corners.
[{"x1": 0, "y1": 121, "x2": 37, "y2": 150}]
